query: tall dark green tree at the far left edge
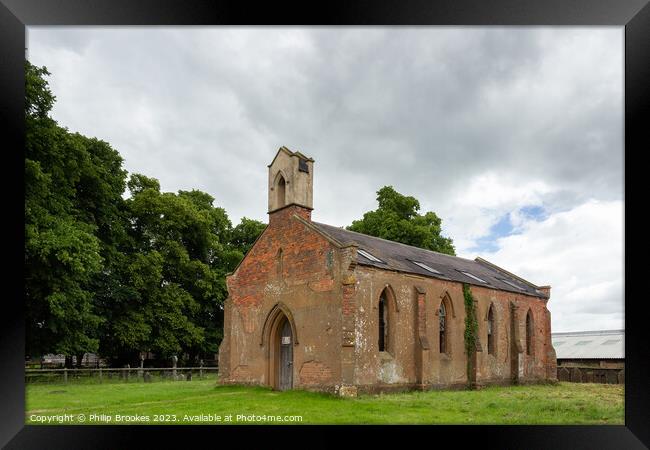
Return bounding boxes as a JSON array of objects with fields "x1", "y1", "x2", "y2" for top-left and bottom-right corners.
[{"x1": 25, "y1": 61, "x2": 126, "y2": 362}]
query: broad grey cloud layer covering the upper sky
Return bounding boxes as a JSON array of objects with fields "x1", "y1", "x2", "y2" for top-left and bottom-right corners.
[{"x1": 29, "y1": 27, "x2": 622, "y2": 224}]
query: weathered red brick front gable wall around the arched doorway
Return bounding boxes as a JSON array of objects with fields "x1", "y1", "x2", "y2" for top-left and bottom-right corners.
[{"x1": 220, "y1": 205, "x2": 342, "y2": 387}]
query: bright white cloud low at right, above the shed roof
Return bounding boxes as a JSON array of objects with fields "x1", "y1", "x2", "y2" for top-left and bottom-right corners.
[{"x1": 483, "y1": 200, "x2": 624, "y2": 331}]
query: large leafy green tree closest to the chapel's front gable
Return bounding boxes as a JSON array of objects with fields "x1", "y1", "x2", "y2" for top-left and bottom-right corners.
[{"x1": 105, "y1": 174, "x2": 263, "y2": 362}]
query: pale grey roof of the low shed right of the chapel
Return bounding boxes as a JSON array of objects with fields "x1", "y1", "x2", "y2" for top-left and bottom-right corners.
[{"x1": 551, "y1": 330, "x2": 625, "y2": 359}]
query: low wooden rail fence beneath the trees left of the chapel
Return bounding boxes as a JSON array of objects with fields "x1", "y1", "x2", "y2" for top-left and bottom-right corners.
[{"x1": 25, "y1": 366, "x2": 219, "y2": 384}]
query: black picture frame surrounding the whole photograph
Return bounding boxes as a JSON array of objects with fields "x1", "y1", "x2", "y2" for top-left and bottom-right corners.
[{"x1": 0, "y1": 0, "x2": 650, "y2": 449}]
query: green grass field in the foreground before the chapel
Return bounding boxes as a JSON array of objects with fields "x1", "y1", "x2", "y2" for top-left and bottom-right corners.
[{"x1": 26, "y1": 379, "x2": 624, "y2": 425}]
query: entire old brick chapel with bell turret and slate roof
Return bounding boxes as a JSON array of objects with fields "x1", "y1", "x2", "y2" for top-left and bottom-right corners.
[{"x1": 219, "y1": 147, "x2": 556, "y2": 395}]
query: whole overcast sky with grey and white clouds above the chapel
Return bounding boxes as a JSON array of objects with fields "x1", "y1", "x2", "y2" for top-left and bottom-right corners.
[{"x1": 27, "y1": 27, "x2": 624, "y2": 331}]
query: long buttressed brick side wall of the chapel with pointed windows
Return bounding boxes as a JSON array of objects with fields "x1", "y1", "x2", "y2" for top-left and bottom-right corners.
[{"x1": 344, "y1": 266, "x2": 551, "y2": 386}]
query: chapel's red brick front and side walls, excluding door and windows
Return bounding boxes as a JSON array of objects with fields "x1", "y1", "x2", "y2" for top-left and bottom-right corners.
[{"x1": 220, "y1": 205, "x2": 552, "y2": 388}]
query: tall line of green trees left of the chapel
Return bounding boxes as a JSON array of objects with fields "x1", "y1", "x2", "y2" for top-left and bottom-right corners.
[{"x1": 25, "y1": 61, "x2": 265, "y2": 364}]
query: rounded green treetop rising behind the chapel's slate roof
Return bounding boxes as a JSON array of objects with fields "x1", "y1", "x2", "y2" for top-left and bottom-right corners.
[{"x1": 347, "y1": 186, "x2": 456, "y2": 255}]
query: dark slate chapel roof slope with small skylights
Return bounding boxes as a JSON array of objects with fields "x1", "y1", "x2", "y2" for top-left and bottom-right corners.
[{"x1": 311, "y1": 222, "x2": 546, "y2": 298}]
